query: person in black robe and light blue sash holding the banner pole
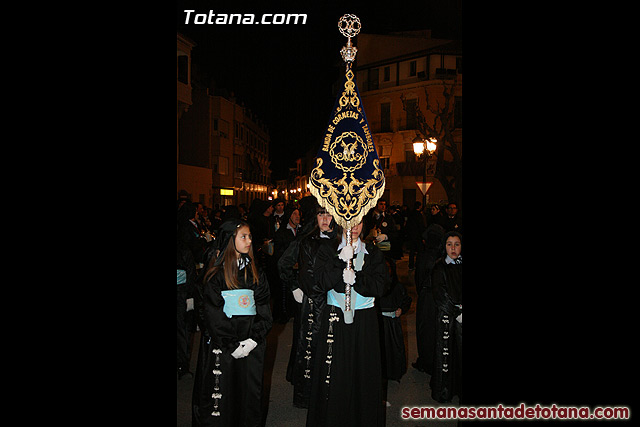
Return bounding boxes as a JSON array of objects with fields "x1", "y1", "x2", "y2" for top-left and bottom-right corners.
[{"x1": 306, "y1": 223, "x2": 390, "y2": 427}]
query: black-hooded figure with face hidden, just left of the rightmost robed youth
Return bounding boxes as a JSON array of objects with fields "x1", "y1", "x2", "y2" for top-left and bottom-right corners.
[{"x1": 411, "y1": 223, "x2": 444, "y2": 375}]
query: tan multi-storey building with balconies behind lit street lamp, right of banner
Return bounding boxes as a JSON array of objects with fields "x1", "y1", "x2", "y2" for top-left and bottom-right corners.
[{"x1": 356, "y1": 30, "x2": 462, "y2": 208}]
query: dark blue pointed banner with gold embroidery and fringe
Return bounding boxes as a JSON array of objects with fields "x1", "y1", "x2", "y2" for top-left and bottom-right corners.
[{"x1": 309, "y1": 63, "x2": 385, "y2": 229}]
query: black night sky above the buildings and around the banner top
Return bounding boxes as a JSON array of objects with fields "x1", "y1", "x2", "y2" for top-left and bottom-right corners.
[{"x1": 176, "y1": 0, "x2": 462, "y2": 179}]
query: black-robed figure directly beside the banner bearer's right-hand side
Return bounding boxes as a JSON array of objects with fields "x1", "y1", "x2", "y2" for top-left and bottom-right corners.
[{"x1": 379, "y1": 259, "x2": 411, "y2": 386}]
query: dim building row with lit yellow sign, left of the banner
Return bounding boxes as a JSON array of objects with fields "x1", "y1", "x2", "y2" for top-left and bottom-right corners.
[{"x1": 176, "y1": 33, "x2": 272, "y2": 208}]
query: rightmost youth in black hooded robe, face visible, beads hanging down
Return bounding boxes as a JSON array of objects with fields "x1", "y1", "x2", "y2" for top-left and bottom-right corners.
[{"x1": 429, "y1": 231, "x2": 462, "y2": 403}]
